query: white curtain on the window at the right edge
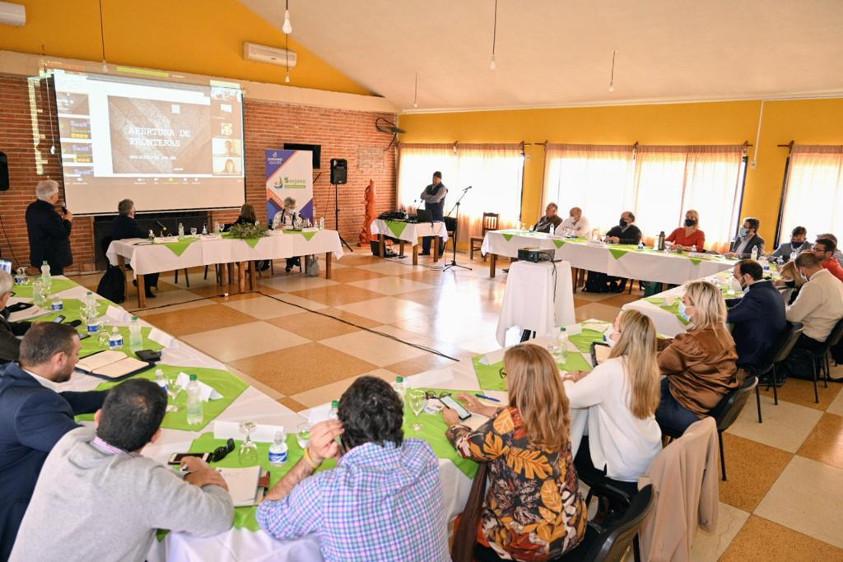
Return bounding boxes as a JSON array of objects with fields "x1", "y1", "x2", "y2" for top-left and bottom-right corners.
[{"x1": 779, "y1": 145, "x2": 843, "y2": 243}]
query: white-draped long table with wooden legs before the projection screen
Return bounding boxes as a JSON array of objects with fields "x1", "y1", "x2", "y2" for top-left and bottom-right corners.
[{"x1": 106, "y1": 230, "x2": 343, "y2": 308}]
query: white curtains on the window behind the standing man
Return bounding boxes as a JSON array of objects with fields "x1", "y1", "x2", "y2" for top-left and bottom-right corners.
[{"x1": 398, "y1": 144, "x2": 524, "y2": 242}]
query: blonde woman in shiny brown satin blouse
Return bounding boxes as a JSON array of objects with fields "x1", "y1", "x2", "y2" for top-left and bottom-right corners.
[{"x1": 656, "y1": 281, "x2": 738, "y2": 437}]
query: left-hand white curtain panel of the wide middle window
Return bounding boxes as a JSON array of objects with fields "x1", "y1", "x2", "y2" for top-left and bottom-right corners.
[{"x1": 542, "y1": 144, "x2": 634, "y2": 231}]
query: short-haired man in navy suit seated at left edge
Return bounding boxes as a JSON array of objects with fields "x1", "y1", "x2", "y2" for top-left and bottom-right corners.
[{"x1": 0, "y1": 322, "x2": 106, "y2": 561}]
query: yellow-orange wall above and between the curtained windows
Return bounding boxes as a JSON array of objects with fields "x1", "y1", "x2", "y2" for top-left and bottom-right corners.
[{"x1": 401, "y1": 99, "x2": 843, "y2": 240}]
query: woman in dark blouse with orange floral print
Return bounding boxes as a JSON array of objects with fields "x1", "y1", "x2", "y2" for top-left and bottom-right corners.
[{"x1": 442, "y1": 344, "x2": 588, "y2": 561}]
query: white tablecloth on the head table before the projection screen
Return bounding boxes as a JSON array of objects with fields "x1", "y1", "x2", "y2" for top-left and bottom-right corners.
[{"x1": 106, "y1": 230, "x2": 343, "y2": 275}]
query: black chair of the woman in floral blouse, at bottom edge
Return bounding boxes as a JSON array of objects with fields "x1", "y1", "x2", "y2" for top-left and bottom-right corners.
[{"x1": 556, "y1": 485, "x2": 653, "y2": 562}]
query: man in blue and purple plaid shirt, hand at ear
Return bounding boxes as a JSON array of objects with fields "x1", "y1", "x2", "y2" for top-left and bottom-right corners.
[{"x1": 257, "y1": 377, "x2": 450, "y2": 562}]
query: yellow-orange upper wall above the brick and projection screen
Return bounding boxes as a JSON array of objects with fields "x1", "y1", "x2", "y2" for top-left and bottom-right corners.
[{"x1": 0, "y1": 0, "x2": 371, "y2": 94}]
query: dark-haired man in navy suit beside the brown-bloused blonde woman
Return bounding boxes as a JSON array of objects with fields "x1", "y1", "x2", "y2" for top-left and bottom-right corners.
[{"x1": 726, "y1": 260, "x2": 787, "y2": 371}]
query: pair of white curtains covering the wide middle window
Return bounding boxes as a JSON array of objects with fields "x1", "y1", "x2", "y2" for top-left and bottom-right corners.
[{"x1": 544, "y1": 145, "x2": 744, "y2": 250}]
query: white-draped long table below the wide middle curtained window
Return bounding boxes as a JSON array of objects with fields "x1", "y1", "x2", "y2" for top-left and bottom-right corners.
[{"x1": 481, "y1": 230, "x2": 735, "y2": 285}]
